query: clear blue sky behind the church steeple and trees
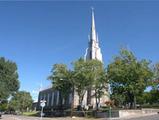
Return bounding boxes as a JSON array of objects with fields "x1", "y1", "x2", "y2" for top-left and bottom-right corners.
[{"x1": 0, "y1": 1, "x2": 159, "y2": 99}]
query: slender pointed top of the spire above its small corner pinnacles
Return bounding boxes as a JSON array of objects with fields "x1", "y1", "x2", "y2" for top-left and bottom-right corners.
[{"x1": 90, "y1": 8, "x2": 96, "y2": 40}]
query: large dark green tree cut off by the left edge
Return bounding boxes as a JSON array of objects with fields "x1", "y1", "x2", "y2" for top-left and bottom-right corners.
[{"x1": 0, "y1": 57, "x2": 19, "y2": 100}]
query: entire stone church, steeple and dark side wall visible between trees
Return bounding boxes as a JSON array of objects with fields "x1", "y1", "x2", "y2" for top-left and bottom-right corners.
[{"x1": 38, "y1": 10, "x2": 109, "y2": 111}]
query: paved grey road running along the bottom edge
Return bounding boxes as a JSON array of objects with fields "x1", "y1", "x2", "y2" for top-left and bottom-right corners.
[{"x1": 1, "y1": 114, "x2": 159, "y2": 120}]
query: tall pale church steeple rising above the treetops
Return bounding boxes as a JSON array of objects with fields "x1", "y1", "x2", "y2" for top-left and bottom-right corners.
[{"x1": 85, "y1": 8, "x2": 102, "y2": 62}]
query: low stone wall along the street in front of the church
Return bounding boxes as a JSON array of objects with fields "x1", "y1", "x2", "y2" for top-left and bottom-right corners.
[{"x1": 42, "y1": 109, "x2": 159, "y2": 118}]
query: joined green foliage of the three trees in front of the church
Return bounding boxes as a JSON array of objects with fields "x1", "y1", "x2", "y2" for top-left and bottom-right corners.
[{"x1": 48, "y1": 58, "x2": 107, "y2": 109}]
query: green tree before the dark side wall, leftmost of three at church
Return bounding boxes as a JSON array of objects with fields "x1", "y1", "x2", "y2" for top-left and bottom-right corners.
[{"x1": 48, "y1": 64, "x2": 72, "y2": 106}]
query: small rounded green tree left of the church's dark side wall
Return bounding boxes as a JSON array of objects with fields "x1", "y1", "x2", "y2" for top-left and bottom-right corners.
[{"x1": 9, "y1": 91, "x2": 33, "y2": 113}]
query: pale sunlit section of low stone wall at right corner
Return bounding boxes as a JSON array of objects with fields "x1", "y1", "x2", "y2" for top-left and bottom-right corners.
[{"x1": 119, "y1": 109, "x2": 159, "y2": 117}]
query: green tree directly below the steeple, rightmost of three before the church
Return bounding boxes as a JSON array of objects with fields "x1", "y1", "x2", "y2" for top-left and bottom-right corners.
[{"x1": 86, "y1": 60, "x2": 108, "y2": 110}]
